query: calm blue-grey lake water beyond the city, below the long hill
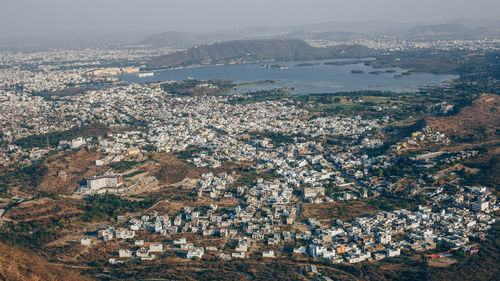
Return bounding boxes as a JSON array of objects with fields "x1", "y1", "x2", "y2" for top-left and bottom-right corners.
[{"x1": 118, "y1": 60, "x2": 456, "y2": 94}]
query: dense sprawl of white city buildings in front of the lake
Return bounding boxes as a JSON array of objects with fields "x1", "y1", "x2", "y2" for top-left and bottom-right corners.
[{"x1": 0, "y1": 43, "x2": 499, "y2": 272}]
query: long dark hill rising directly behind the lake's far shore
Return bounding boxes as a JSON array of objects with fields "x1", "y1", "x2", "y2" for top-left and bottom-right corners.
[{"x1": 148, "y1": 39, "x2": 375, "y2": 68}]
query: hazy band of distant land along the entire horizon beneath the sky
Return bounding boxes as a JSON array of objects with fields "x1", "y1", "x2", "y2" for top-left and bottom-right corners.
[{"x1": 0, "y1": 19, "x2": 500, "y2": 50}]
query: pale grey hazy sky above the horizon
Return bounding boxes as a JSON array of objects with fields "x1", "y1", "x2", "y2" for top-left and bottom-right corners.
[{"x1": 0, "y1": 0, "x2": 500, "y2": 36}]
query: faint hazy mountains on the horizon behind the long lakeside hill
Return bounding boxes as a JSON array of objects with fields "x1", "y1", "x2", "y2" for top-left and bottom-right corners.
[{"x1": 137, "y1": 20, "x2": 500, "y2": 48}]
